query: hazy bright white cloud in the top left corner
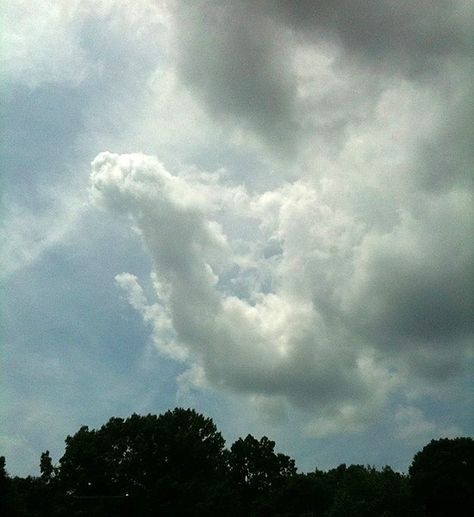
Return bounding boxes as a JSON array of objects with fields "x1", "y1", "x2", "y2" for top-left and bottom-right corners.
[{"x1": 2, "y1": 0, "x2": 167, "y2": 88}]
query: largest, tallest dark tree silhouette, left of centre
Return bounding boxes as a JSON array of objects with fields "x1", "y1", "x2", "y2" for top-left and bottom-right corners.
[{"x1": 58, "y1": 408, "x2": 224, "y2": 515}]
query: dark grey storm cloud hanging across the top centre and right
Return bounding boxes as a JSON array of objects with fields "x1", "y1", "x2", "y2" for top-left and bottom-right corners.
[{"x1": 174, "y1": 0, "x2": 474, "y2": 158}]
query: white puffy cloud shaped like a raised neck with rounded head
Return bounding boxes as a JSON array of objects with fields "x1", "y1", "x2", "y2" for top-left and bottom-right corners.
[{"x1": 91, "y1": 153, "x2": 385, "y2": 424}]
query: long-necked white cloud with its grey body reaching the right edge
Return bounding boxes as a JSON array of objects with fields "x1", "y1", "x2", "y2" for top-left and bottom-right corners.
[{"x1": 91, "y1": 135, "x2": 472, "y2": 435}]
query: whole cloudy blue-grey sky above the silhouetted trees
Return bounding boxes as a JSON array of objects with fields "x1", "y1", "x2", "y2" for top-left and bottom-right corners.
[{"x1": 0, "y1": 0, "x2": 474, "y2": 475}]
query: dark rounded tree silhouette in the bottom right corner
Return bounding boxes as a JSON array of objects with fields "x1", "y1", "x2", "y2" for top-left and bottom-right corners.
[{"x1": 409, "y1": 438, "x2": 474, "y2": 517}]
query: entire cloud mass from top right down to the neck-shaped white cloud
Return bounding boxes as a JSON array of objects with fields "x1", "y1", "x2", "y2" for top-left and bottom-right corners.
[{"x1": 87, "y1": 0, "x2": 474, "y2": 435}]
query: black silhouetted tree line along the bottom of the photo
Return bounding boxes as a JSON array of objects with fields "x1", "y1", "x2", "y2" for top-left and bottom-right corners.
[{"x1": 0, "y1": 408, "x2": 474, "y2": 517}]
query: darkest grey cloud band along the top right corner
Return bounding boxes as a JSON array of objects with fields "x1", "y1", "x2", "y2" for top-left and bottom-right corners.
[{"x1": 262, "y1": 0, "x2": 473, "y2": 75}]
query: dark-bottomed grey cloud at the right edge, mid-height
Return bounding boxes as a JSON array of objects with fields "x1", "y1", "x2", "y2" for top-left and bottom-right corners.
[{"x1": 347, "y1": 191, "x2": 474, "y2": 345}]
